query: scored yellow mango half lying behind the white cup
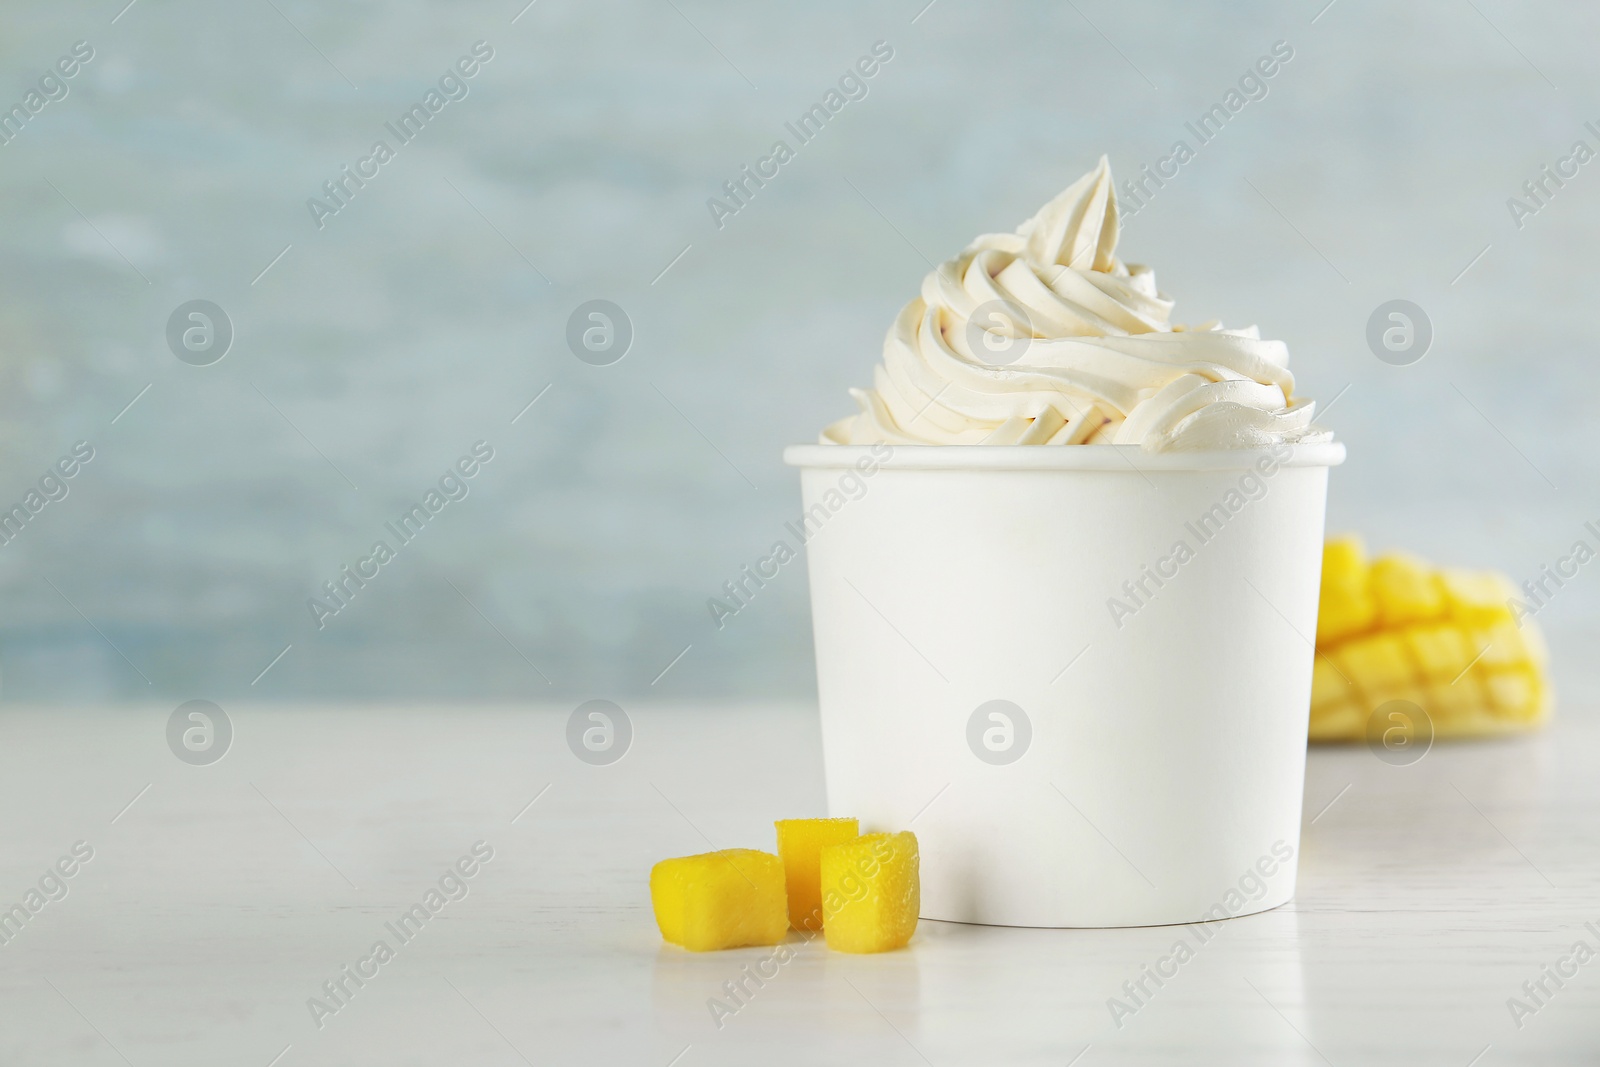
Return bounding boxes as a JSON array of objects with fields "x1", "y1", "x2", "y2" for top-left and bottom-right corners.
[{"x1": 1310, "y1": 536, "x2": 1550, "y2": 741}]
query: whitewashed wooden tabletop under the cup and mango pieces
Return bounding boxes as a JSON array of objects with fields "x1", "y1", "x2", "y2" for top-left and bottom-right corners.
[{"x1": 0, "y1": 705, "x2": 1600, "y2": 1067}]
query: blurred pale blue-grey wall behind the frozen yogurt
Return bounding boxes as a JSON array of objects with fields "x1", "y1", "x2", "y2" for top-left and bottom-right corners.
[{"x1": 0, "y1": 0, "x2": 1600, "y2": 710}]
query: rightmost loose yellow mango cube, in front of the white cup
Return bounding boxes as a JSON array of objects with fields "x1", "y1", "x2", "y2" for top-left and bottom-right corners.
[{"x1": 821, "y1": 830, "x2": 922, "y2": 952}]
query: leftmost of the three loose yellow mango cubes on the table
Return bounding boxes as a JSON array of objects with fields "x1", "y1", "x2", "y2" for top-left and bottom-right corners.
[{"x1": 650, "y1": 848, "x2": 789, "y2": 952}]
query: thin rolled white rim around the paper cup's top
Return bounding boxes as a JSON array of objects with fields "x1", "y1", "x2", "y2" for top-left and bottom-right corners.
[{"x1": 784, "y1": 442, "x2": 1344, "y2": 470}]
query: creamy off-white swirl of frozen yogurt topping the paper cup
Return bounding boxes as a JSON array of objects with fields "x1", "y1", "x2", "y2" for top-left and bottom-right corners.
[{"x1": 822, "y1": 157, "x2": 1331, "y2": 451}]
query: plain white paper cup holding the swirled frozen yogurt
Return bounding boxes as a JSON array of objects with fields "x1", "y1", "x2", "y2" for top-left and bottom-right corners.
[{"x1": 784, "y1": 443, "x2": 1344, "y2": 926}]
